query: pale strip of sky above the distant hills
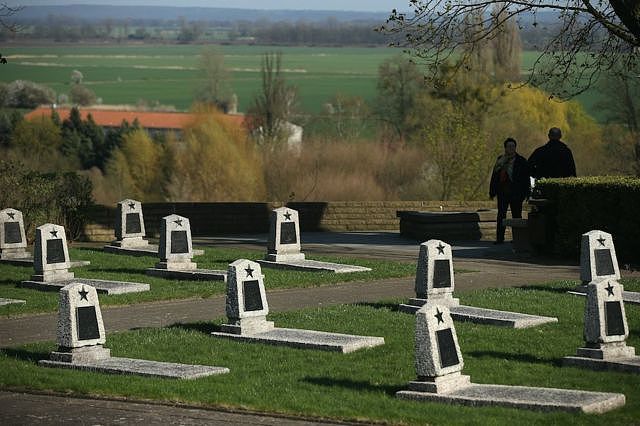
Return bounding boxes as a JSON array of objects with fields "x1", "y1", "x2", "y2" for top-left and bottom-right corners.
[{"x1": 6, "y1": 0, "x2": 408, "y2": 12}]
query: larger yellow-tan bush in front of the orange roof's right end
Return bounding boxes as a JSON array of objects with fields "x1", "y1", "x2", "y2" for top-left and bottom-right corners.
[{"x1": 169, "y1": 107, "x2": 266, "y2": 201}]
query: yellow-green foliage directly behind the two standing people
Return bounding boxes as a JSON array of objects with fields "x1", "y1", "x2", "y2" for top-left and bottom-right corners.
[{"x1": 486, "y1": 86, "x2": 605, "y2": 175}]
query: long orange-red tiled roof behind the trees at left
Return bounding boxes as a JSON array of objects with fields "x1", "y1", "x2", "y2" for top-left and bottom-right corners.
[{"x1": 24, "y1": 107, "x2": 244, "y2": 130}]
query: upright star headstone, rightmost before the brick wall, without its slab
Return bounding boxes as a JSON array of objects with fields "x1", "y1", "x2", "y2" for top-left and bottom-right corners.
[{"x1": 266, "y1": 207, "x2": 304, "y2": 262}]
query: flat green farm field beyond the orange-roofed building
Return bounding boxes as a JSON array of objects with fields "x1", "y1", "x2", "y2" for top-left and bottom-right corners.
[{"x1": 0, "y1": 44, "x2": 603, "y2": 119}]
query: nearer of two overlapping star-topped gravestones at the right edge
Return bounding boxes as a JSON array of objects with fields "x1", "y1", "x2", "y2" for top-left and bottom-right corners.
[{"x1": 563, "y1": 280, "x2": 640, "y2": 373}]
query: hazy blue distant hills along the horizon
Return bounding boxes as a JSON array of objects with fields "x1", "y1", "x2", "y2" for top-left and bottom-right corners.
[{"x1": 13, "y1": 4, "x2": 389, "y2": 22}]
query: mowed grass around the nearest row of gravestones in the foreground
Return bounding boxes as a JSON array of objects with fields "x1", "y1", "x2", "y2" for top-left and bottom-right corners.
[{"x1": 0, "y1": 281, "x2": 640, "y2": 425}]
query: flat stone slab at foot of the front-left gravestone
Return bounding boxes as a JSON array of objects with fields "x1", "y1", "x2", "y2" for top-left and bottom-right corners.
[{"x1": 39, "y1": 357, "x2": 229, "y2": 379}]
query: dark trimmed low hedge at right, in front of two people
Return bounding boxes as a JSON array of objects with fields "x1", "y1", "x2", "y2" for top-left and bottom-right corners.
[{"x1": 534, "y1": 176, "x2": 640, "y2": 263}]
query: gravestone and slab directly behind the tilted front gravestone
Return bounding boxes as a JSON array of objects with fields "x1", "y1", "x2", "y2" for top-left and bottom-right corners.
[{"x1": 398, "y1": 240, "x2": 558, "y2": 328}]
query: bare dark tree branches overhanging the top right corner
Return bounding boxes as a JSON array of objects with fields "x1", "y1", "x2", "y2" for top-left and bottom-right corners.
[{"x1": 379, "y1": 0, "x2": 640, "y2": 98}]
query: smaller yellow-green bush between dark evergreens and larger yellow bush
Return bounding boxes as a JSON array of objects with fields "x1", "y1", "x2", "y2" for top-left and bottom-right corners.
[{"x1": 107, "y1": 129, "x2": 165, "y2": 202}]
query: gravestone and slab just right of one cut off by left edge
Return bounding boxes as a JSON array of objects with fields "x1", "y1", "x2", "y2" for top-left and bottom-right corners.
[{"x1": 20, "y1": 223, "x2": 149, "y2": 294}]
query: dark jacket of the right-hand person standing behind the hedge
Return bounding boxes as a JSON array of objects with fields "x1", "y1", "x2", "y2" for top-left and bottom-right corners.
[{"x1": 529, "y1": 140, "x2": 576, "y2": 179}]
